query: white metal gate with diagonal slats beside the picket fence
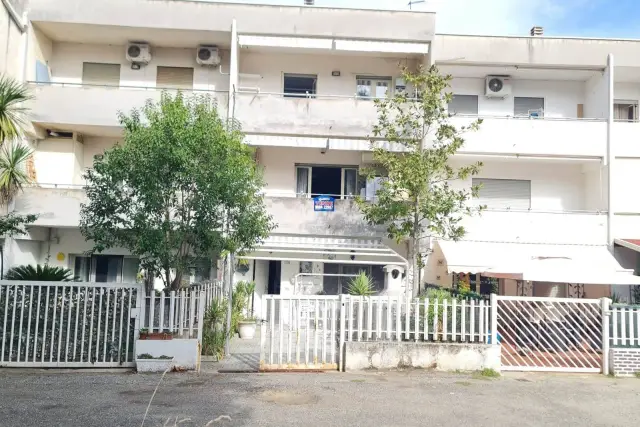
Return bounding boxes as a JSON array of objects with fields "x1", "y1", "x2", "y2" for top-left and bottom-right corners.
[{"x1": 494, "y1": 296, "x2": 603, "y2": 372}]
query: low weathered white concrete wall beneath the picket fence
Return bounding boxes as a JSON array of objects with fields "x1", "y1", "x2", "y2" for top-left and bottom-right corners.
[{"x1": 344, "y1": 341, "x2": 501, "y2": 372}]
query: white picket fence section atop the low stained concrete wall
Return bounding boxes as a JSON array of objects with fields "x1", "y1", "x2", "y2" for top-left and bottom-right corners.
[{"x1": 341, "y1": 295, "x2": 490, "y2": 342}]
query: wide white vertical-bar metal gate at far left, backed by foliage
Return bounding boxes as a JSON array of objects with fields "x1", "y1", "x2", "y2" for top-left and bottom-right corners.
[{"x1": 0, "y1": 281, "x2": 143, "y2": 368}]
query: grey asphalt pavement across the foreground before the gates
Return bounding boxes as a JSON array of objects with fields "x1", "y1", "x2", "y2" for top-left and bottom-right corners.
[{"x1": 0, "y1": 370, "x2": 640, "y2": 427}]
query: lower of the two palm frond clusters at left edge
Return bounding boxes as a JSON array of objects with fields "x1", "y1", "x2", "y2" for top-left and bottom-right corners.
[{"x1": 0, "y1": 141, "x2": 33, "y2": 203}]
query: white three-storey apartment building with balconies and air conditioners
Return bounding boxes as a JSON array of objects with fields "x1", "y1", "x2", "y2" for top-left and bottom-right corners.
[{"x1": 5, "y1": 0, "x2": 640, "y2": 310}]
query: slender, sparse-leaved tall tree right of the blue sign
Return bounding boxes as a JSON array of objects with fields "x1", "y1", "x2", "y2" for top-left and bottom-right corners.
[{"x1": 358, "y1": 66, "x2": 482, "y2": 294}]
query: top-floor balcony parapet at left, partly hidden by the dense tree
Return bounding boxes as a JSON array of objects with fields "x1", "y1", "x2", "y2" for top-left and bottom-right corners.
[{"x1": 30, "y1": 83, "x2": 228, "y2": 132}]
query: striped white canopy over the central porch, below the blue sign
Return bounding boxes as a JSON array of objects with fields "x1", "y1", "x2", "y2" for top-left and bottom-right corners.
[{"x1": 238, "y1": 234, "x2": 407, "y2": 266}]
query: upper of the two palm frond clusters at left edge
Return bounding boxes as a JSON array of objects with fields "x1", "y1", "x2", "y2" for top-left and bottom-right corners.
[{"x1": 0, "y1": 76, "x2": 33, "y2": 143}]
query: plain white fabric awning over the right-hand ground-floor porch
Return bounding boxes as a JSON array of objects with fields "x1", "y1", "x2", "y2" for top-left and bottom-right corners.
[{"x1": 437, "y1": 241, "x2": 640, "y2": 285}]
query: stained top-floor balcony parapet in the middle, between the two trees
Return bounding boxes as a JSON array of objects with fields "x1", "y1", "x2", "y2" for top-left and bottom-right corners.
[{"x1": 235, "y1": 92, "x2": 377, "y2": 137}]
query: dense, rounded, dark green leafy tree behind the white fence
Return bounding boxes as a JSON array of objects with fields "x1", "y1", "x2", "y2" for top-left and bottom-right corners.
[{"x1": 80, "y1": 93, "x2": 273, "y2": 289}]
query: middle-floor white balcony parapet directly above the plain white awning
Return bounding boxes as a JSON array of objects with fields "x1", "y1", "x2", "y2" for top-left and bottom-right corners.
[{"x1": 464, "y1": 210, "x2": 607, "y2": 245}]
